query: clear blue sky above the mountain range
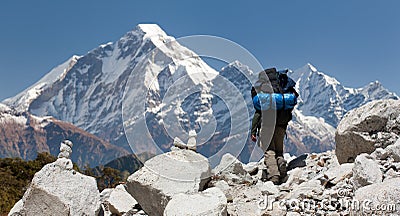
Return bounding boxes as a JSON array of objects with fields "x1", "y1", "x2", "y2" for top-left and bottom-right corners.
[{"x1": 0, "y1": 0, "x2": 400, "y2": 101}]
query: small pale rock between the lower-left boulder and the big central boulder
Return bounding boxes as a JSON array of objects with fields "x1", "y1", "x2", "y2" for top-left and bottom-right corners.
[{"x1": 101, "y1": 185, "x2": 138, "y2": 215}]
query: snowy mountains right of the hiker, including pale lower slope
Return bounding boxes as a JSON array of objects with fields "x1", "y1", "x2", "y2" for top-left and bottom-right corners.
[{"x1": 286, "y1": 63, "x2": 399, "y2": 155}]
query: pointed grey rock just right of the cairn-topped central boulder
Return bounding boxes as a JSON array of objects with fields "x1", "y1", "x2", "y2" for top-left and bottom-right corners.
[{"x1": 212, "y1": 153, "x2": 253, "y2": 183}]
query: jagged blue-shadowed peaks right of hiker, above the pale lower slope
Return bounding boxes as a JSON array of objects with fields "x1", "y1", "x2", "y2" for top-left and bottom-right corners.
[{"x1": 290, "y1": 64, "x2": 398, "y2": 128}]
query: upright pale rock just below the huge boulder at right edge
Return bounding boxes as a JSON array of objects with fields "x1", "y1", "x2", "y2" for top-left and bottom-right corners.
[{"x1": 352, "y1": 153, "x2": 382, "y2": 189}]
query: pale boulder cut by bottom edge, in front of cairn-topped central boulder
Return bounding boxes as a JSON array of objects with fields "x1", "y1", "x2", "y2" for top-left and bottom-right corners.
[{"x1": 164, "y1": 187, "x2": 227, "y2": 216}]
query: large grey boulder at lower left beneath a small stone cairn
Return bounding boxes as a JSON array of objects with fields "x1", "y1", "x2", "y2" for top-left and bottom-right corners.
[{"x1": 10, "y1": 157, "x2": 100, "y2": 215}]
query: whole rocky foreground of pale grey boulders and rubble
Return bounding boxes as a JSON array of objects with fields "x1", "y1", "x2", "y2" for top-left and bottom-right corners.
[{"x1": 9, "y1": 101, "x2": 400, "y2": 216}]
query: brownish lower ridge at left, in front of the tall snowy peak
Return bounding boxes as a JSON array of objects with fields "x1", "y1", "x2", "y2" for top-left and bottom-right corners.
[{"x1": 0, "y1": 105, "x2": 128, "y2": 167}]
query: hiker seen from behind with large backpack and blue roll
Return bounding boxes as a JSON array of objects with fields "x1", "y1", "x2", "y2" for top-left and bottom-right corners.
[{"x1": 251, "y1": 68, "x2": 299, "y2": 184}]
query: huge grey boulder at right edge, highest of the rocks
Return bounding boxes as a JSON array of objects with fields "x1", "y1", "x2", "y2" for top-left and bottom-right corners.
[{"x1": 335, "y1": 100, "x2": 400, "y2": 163}]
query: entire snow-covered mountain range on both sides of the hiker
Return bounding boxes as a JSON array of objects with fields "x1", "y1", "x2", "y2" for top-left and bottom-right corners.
[{"x1": 4, "y1": 24, "x2": 397, "y2": 161}]
